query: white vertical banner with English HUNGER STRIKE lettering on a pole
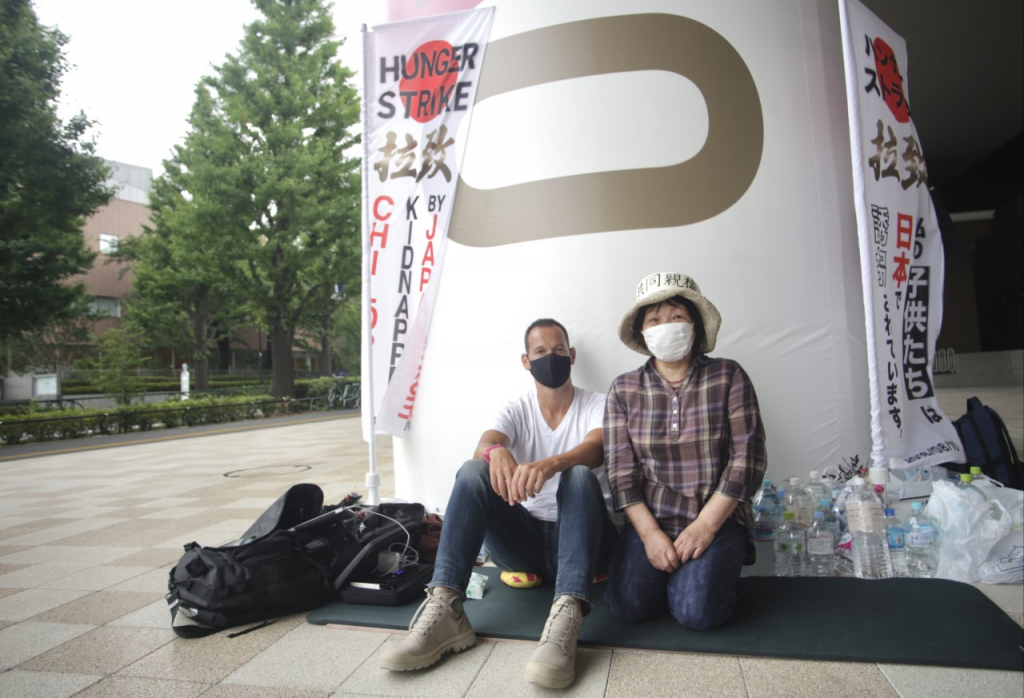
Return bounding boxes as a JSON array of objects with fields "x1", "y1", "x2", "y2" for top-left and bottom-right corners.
[{"x1": 362, "y1": 7, "x2": 495, "y2": 441}]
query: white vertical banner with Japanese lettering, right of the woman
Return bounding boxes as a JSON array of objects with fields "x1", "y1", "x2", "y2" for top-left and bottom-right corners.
[{"x1": 839, "y1": 0, "x2": 964, "y2": 468}]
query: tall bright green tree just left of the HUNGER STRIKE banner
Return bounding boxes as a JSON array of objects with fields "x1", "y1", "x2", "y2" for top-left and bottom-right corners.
[{"x1": 178, "y1": 0, "x2": 360, "y2": 397}]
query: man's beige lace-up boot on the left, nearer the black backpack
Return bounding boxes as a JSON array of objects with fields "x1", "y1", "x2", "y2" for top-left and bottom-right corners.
[{"x1": 380, "y1": 586, "x2": 476, "y2": 671}]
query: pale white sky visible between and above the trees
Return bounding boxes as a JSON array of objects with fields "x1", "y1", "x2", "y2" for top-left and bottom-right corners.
[{"x1": 33, "y1": 0, "x2": 387, "y2": 177}]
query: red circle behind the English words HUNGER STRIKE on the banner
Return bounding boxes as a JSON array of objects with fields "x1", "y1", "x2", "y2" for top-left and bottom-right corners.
[{"x1": 398, "y1": 41, "x2": 461, "y2": 124}]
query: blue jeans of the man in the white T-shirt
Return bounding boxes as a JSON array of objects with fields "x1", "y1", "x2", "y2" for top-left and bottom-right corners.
[{"x1": 429, "y1": 460, "x2": 616, "y2": 612}]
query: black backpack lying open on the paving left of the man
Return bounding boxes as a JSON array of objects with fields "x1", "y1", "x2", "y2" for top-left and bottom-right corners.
[{"x1": 167, "y1": 484, "x2": 423, "y2": 638}]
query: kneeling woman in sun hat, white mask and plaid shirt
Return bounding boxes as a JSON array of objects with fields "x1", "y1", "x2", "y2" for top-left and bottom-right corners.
[{"x1": 604, "y1": 273, "x2": 766, "y2": 629}]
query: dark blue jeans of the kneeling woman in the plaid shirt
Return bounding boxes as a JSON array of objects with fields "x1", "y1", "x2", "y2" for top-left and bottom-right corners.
[{"x1": 604, "y1": 519, "x2": 746, "y2": 630}]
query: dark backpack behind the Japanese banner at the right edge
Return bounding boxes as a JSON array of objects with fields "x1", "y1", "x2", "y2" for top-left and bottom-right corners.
[{"x1": 946, "y1": 397, "x2": 1024, "y2": 489}]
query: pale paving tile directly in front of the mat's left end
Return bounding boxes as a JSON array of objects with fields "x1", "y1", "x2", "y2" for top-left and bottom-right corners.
[{"x1": 222, "y1": 622, "x2": 388, "y2": 693}]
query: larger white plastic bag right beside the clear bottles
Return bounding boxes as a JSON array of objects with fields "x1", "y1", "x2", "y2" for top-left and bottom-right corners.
[{"x1": 925, "y1": 481, "x2": 1013, "y2": 583}]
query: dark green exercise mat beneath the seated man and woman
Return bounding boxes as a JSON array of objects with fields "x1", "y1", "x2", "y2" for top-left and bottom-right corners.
[{"x1": 308, "y1": 568, "x2": 1024, "y2": 670}]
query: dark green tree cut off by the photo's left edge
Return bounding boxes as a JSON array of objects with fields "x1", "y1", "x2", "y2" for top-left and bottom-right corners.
[{"x1": 0, "y1": 0, "x2": 113, "y2": 370}]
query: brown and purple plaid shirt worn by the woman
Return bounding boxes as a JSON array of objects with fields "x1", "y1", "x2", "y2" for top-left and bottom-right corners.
[{"x1": 604, "y1": 357, "x2": 767, "y2": 563}]
